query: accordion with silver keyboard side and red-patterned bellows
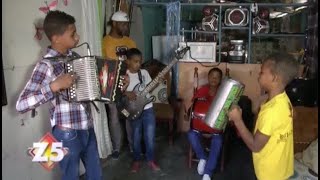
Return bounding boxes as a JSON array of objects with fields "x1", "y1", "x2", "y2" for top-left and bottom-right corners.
[{"x1": 65, "y1": 56, "x2": 126, "y2": 102}]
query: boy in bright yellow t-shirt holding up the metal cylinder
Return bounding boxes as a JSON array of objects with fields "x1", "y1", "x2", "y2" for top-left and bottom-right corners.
[{"x1": 228, "y1": 53, "x2": 298, "y2": 180}]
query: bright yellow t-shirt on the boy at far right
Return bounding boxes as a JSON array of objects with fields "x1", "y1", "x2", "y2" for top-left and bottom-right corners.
[{"x1": 253, "y1": 92, "x2": 294, "y2": 180}]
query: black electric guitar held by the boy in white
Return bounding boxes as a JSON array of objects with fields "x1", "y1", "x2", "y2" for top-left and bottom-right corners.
[{"x1": 119, "y1": 47, "x2": 189, "y2": 120}]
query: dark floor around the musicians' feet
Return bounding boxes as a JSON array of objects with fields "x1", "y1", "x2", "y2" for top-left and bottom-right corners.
[{"x1": 99, "y1": 124, "x2": 255, "y2": 180}]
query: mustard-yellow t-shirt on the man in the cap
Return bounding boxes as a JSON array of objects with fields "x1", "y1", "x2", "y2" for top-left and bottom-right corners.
[{"x1": 102, "y1": 35, "x2": 136, "y2": 60}]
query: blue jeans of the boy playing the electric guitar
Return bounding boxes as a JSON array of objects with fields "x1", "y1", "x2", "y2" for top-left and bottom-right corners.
[{"x1": 130, "y1": 108, "x2": 156, "y2": 161}]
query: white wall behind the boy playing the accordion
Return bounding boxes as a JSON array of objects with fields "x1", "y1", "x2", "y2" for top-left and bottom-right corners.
[{"x1": 2, "y1": 0, "x2": 86, "y2": 180}]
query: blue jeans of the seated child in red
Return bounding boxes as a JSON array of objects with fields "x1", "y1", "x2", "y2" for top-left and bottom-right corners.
[{"x1": 188, "y1": 129, "x2": 222, "y2": 176}]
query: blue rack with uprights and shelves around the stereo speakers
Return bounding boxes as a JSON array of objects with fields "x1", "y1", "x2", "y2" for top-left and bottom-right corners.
[{"x1": 134, "y1": 0, "x2": 309, "y2": 64}]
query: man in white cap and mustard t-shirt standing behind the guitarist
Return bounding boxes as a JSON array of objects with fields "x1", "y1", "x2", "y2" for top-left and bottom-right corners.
[{"x1": 102, "y1": 11, "x2": 136, "y2": 159}]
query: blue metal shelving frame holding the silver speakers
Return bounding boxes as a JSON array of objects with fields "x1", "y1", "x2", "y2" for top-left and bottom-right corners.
[{"x1": 135, "y1": 1, "x2": 308, "y2": 63}]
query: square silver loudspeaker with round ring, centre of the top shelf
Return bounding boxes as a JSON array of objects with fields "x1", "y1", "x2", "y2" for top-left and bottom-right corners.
[{"x1": 224, "y1": 8, "x2": 249, "y2": 26}]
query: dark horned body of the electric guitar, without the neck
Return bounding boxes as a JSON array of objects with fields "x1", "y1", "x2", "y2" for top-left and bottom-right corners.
[{"x1": 120, "y1": 84, "x2": 154, "y2": 120}]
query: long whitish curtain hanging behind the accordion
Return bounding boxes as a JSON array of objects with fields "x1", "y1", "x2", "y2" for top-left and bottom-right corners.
[{"x1": 81, "y1": 0, "x2": 112, "y2": 158}]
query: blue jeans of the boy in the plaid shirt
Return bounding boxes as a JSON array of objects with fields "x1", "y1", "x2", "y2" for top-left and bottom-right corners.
[{"x1": 52, "y1": 127, "x2": 102, "y2": 180}]
